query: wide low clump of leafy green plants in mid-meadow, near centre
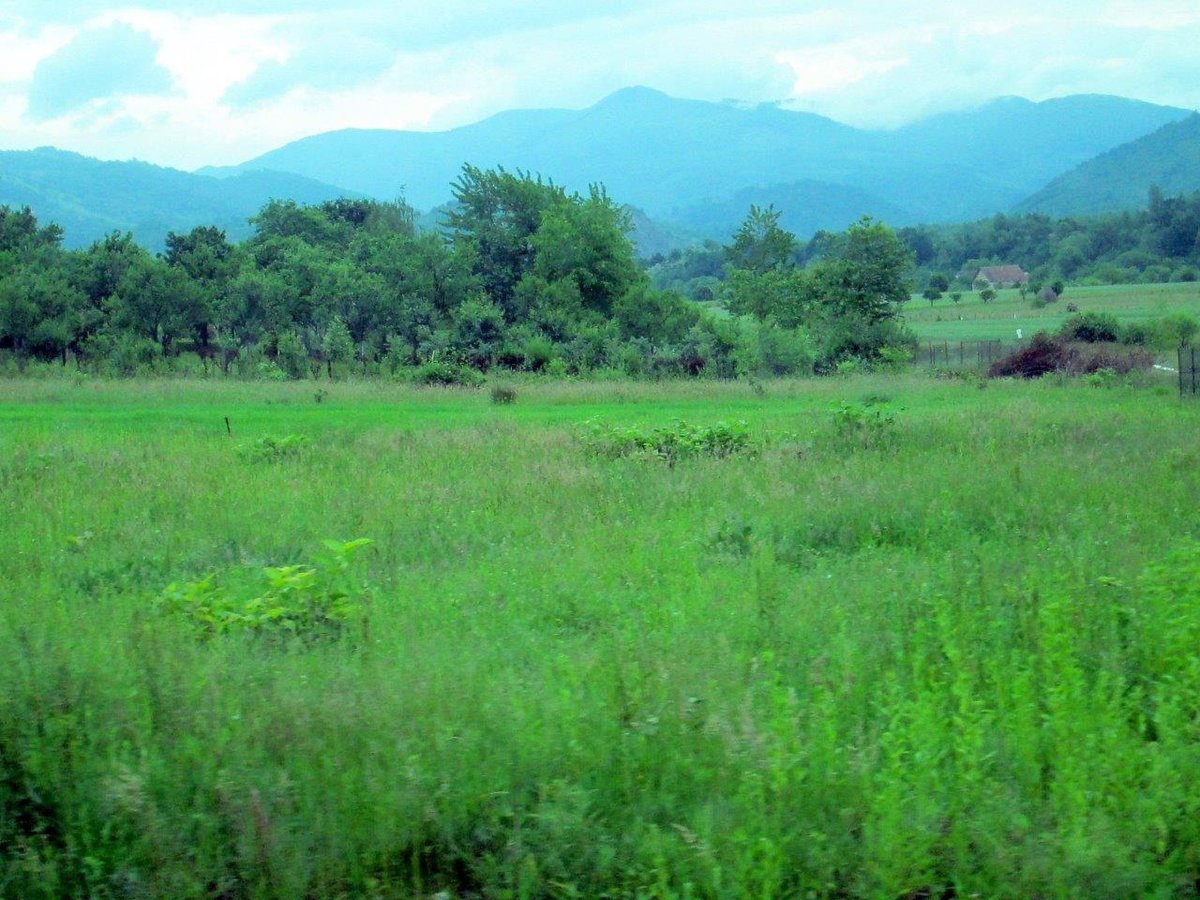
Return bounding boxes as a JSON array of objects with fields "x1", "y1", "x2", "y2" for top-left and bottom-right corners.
[{"x1": 584, "y1": 421, "x2": 761, "y2": 466}]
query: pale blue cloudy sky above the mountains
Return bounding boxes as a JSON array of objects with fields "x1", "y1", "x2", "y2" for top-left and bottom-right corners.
[{"x1": 0, "y1": 0, "x2": 1200, "y2": 169}]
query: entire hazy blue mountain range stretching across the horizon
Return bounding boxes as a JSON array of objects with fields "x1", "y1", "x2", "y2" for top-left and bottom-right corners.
[{"x1": 0, "y1": 88, "x2": 1200, "y2": 252}]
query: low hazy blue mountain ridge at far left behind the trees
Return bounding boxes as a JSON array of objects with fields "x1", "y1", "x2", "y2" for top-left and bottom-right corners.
[{"x1": 0, "y1": 148, "x2": 358, "y2": 250}]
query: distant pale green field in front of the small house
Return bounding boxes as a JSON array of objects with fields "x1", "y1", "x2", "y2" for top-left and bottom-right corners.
[{"x1": 904, "y1": 282, "x2": 1200, "y2": 341}]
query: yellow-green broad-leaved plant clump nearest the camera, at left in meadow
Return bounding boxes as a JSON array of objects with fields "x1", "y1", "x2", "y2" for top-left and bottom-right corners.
[{"x1": 156, "y1": 538, "x2": 373, "y2": 643}]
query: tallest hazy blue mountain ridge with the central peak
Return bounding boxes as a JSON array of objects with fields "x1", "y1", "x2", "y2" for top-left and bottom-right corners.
[{"x1": 211, "y1": 88, "x2": 1188, "y2": 238}]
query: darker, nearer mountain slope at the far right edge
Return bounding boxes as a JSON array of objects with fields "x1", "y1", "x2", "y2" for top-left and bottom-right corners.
[{"x1": 1018, "y1": 113, "x2": 1200, "y2": 216}]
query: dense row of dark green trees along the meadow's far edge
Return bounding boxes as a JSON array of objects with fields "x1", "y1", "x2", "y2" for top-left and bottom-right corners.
[{"x1": 0, "y1": 166, "x2": 911, "y2": 382}]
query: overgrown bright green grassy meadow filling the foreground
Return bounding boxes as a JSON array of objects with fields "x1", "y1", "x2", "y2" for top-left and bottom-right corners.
[{"x1": 0, "y1": 377, "x2": 1200, "y2": 898}]
